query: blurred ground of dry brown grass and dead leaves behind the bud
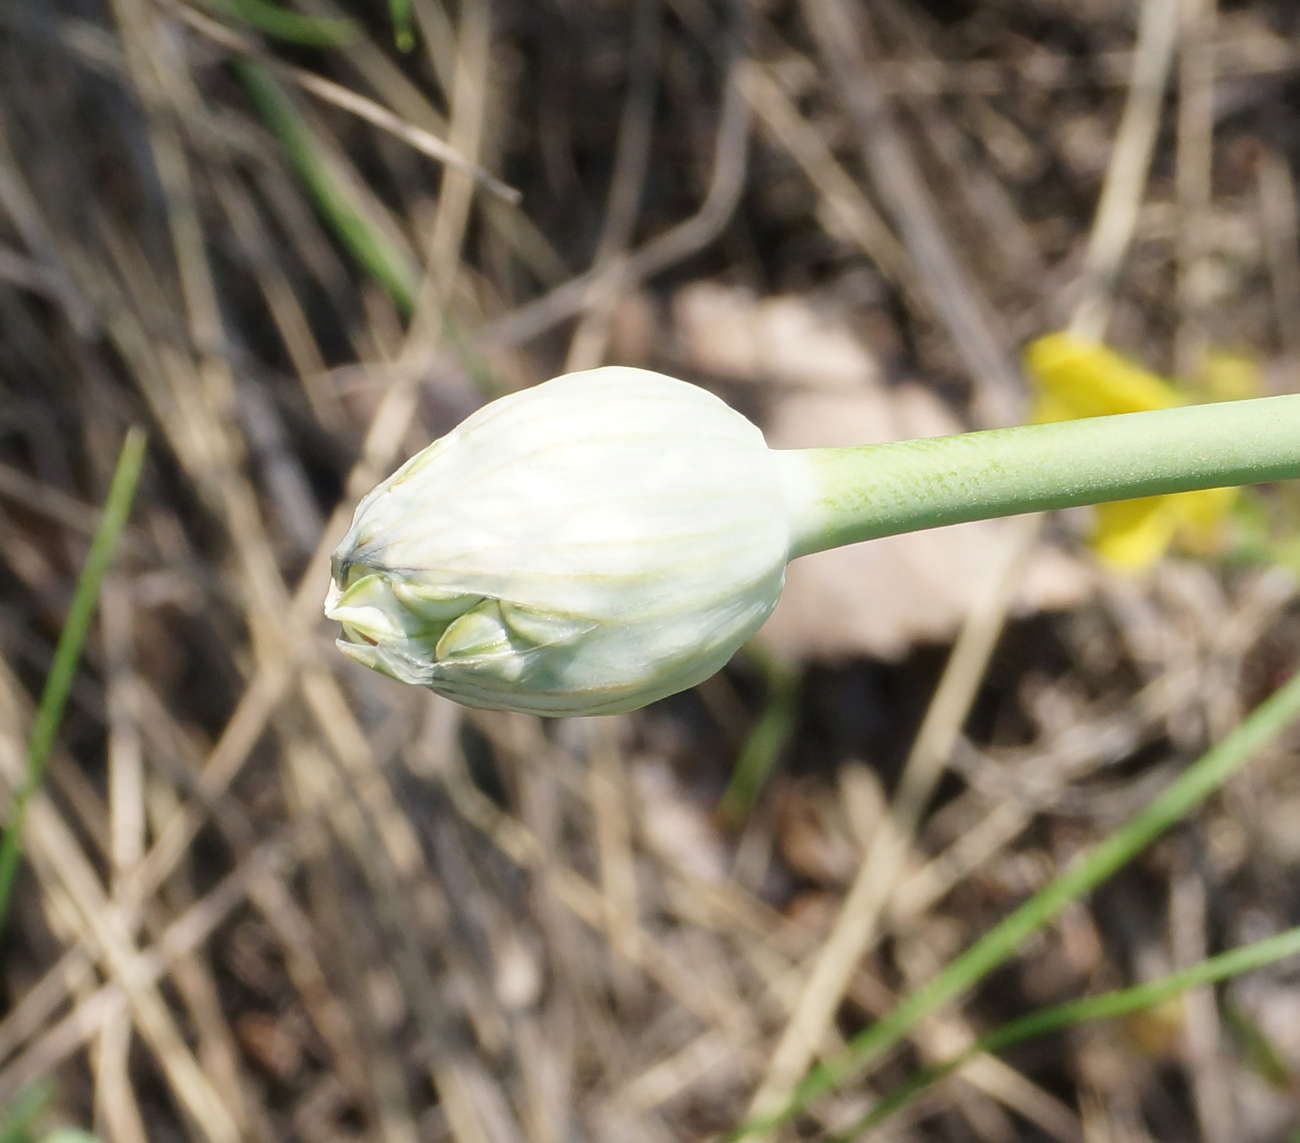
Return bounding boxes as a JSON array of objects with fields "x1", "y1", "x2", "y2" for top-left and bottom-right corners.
[{"x1": 0, "y1": 0, "x2": 1300, "y2": 1143}]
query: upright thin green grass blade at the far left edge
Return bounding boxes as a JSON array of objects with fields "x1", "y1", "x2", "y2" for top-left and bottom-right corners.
[{"x1": 0, "y1": 428, "x2": 144, "y2": 931}]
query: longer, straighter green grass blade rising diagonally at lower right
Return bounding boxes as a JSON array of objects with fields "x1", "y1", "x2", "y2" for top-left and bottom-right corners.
[{"x1": 727, "y1": 674, "x2": 1300, "y2": 1140}]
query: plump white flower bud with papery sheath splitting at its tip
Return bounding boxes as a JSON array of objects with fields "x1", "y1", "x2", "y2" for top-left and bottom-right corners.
[{"x1": 325, "y1": 367, "x2": 790, "y2": 715}]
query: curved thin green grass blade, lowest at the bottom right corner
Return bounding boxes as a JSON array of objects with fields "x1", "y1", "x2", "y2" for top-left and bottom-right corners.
[{"x1": 828, "y1": 928, "x2": 1300, "y2": 1143}]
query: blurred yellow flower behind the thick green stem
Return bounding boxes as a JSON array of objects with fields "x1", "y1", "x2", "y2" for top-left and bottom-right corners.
[{"x1": 1024, "y1": 333, "x2": 1260, "y2": 572}]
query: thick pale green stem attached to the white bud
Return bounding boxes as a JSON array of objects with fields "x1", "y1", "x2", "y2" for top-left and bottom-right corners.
[{"x1": 777, "y1": 395, "x2": 1300, "y2": 558}]
